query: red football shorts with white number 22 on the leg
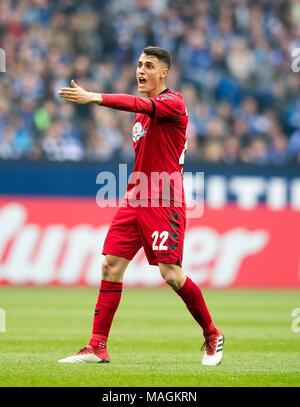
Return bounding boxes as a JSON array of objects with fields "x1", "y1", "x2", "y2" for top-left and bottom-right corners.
[{"x1": 102, "y1": 200, "x2": 186, "y2": 266}]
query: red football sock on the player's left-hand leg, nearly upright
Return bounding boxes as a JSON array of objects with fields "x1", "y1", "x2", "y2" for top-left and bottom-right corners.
[{"x1": 89, "y1": 280, "x2": 123, "y2": 348}]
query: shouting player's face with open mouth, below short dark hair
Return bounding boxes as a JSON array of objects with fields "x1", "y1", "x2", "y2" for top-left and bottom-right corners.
[{"x1": 136, "y1": 54, "x2": 168, "y2": 96}]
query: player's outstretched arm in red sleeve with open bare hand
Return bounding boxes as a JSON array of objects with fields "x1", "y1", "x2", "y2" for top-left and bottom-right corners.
[{"x1": 58, "y1": 79, "x2": 154, "y2": 114}]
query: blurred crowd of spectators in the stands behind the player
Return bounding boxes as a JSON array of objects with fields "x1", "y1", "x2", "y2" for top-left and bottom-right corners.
[{"x1": 0, "y1": 0, "x2": 300, "y2": 166}]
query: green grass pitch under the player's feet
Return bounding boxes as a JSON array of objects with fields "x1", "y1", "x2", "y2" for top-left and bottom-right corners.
[{"x1": 0, "y1": 287, "x2": 300, "y2": 387}]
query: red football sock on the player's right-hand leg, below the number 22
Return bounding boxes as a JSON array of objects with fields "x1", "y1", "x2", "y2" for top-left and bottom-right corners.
[{"x1": 176, "y1": 277, "x2": 218, "y2": 336}]
